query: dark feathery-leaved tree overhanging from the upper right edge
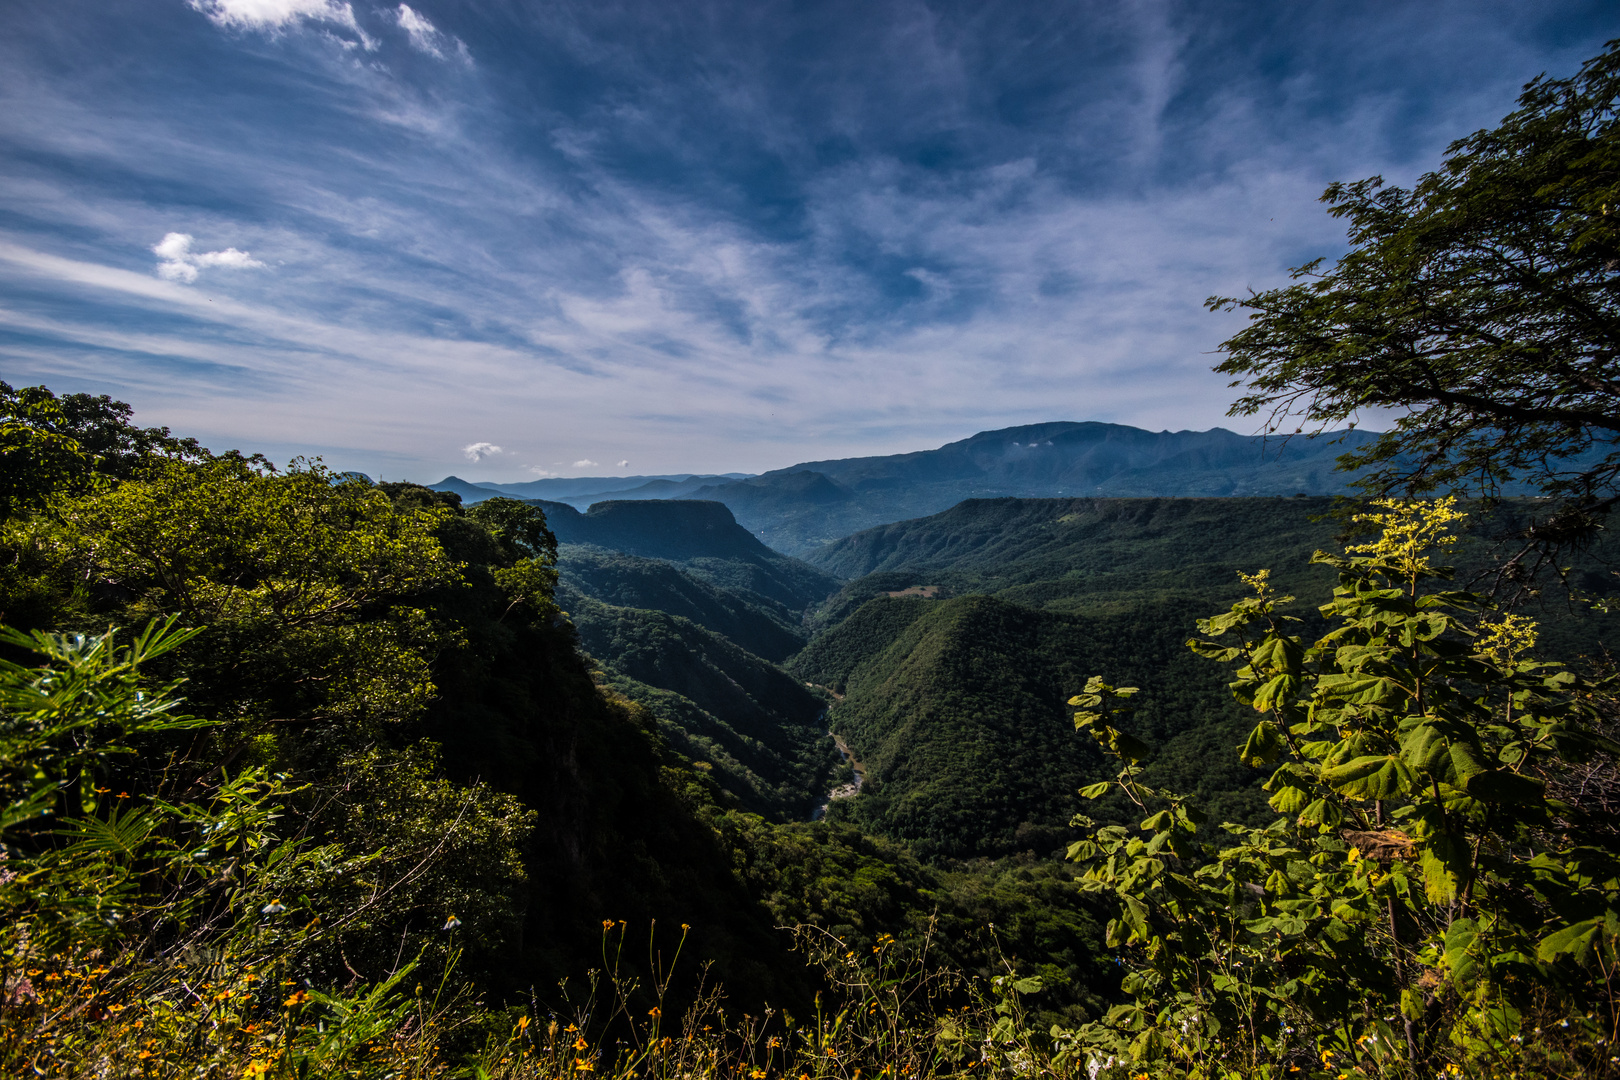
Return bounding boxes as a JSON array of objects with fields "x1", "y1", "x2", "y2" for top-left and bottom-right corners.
[{"x1": 1207, "y1": 40, "x2": 1620, "y2": 566}]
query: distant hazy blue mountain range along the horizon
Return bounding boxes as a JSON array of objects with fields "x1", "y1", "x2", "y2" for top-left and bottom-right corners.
[{"x1": 433, "y1": 421, "x2": 1377, "y2": 555}]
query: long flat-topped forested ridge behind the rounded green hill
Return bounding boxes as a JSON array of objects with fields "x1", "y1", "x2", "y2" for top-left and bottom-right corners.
[{"x1": 808, "y1": 497, "x2": 1620, "y2": 651}]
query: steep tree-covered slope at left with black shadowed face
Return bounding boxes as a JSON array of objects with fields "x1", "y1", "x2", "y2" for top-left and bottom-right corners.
[{"x1": 0, "y1": 408, "x2": 810, "y2": 1016}]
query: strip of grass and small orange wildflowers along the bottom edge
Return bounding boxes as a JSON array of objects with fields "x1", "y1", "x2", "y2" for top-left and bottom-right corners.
[{"x1": 0, "y1": 921, "x2": 1055, "y2": 1080}]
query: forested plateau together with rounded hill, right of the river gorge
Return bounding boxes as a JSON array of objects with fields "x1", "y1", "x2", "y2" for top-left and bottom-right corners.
[{"x1": 789, "y1": 499, "x2": 1617, "y2": 857}]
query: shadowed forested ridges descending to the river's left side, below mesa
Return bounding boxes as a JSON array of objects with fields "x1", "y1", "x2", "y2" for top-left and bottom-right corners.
[{"x1": 531, "y1": 500, "x2": 836, "y2": 821}]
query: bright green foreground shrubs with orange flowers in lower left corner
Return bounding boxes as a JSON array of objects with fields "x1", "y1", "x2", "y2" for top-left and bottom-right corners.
[{"x1": 0, "y1": 620, "x2": 479, "y2": 1077}]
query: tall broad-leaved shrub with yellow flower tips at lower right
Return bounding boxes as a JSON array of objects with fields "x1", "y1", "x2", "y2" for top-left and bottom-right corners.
[{"x1": 1064, "y1": 500, "x2": 1620, "y2": 1077}]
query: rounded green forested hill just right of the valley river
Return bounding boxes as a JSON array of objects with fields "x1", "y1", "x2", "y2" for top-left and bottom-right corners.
[{"x1": 816, "y1": 596, "x2": 1264, "y2": 857}]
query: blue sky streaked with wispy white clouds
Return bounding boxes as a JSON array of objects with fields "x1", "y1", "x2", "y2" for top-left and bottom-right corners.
[{"x1": 0, "y1": 0, "x2": 1620, "y2": 481}]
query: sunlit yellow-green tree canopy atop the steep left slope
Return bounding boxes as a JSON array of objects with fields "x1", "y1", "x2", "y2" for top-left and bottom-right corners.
[{"x1": 5, "y1": 457, "x2": 458, "y2": 757}]
